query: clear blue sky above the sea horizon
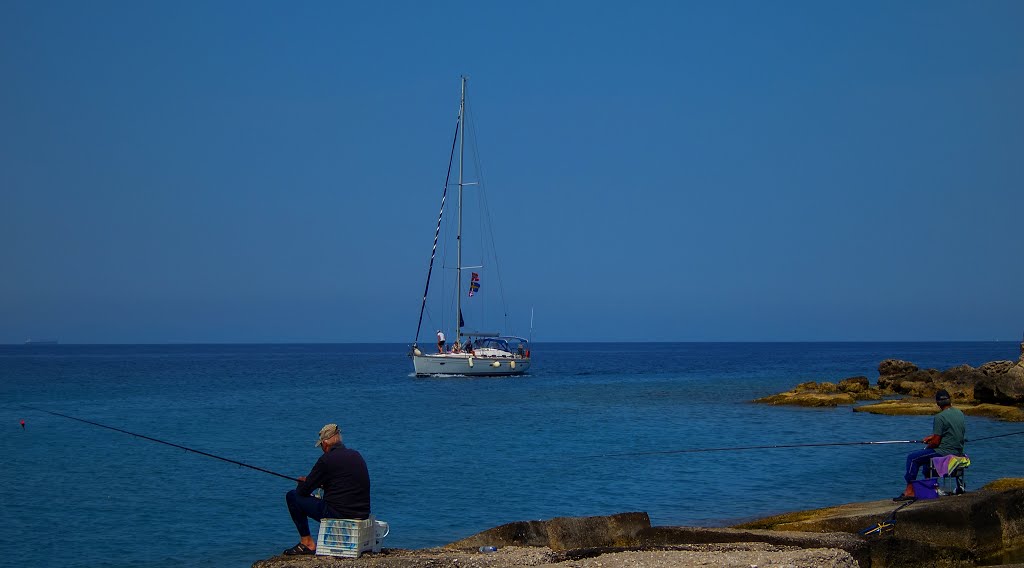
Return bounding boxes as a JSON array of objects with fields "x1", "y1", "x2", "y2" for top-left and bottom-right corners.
[{"x1": 0, "y1": 0, "x2": 1024, "y2": 343}]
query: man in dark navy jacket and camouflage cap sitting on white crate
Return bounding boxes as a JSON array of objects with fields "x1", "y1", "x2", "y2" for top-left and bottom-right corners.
[{"x1": 284, "y1": 424, "x2": 370, "y2": 556}]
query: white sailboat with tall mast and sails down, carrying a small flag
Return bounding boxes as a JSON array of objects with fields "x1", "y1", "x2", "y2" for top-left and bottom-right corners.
[{"x1": 410, "y1": 77, "x2": 530, "y2": 377}]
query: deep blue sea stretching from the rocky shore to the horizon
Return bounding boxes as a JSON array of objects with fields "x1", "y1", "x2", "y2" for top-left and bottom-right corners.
[{"x1": 0, "y1": 342, "x2": 1024, "y2": 568}]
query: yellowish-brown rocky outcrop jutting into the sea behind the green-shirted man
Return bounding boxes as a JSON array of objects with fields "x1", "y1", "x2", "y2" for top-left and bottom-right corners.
[{"x1": 755, "y1": 343, "x2": 1024, "y2": 422}]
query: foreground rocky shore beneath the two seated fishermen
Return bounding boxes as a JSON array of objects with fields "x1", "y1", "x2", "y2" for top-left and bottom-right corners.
[{"x1": 253, "y1": 479, "x2": 1024, "y2": 568}]
